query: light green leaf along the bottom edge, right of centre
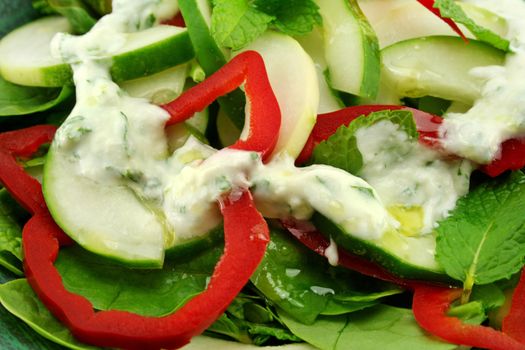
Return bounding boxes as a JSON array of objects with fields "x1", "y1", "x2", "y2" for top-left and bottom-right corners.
[{"x1": 278, "y1": 305, "x2": 457, "y2": 350}]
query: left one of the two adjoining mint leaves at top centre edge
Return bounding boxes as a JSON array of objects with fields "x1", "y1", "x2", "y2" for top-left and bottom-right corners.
[{"x1": 211, "y1": 0, "x2": 274, "y2": 50}]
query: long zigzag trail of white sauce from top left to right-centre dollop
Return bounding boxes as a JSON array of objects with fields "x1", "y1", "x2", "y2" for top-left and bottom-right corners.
[{"x1": 52, "y1": 0, "x2": 488, "y2": 258}]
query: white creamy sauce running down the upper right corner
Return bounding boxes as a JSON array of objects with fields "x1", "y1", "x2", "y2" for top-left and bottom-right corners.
[{"x1": 440, "y1": 0, "x2": 525, "y2": 163}]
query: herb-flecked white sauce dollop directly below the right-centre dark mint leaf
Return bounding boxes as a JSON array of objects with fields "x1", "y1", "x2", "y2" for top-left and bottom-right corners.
[{"x1": 356, "y1": 121, "x2": 472, "y2": 234}]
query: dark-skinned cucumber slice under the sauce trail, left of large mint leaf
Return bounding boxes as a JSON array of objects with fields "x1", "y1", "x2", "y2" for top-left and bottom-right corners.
[{"x1": 312, "y1": 212, "x2": 453, "y2": 283}]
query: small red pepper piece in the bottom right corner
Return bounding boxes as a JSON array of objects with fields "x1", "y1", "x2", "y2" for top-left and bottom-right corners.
[{"x1": 502, "y1": 269, "x2": 525, "y2": 344}]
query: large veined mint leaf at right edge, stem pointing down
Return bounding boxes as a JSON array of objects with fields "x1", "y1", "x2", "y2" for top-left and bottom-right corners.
[{"x1": 436, "y1": 172, "x2": 525, "y2": 302}]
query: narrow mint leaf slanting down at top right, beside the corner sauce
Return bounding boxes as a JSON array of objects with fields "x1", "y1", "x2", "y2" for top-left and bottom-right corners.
[{"x1": 434, "y1": 0, "x2": 510, "y2": 51}]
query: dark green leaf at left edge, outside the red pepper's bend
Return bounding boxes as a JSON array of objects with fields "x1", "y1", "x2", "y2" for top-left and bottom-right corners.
[{"x1": 0, "y1": 189, "x2": 27, "y2": 276}]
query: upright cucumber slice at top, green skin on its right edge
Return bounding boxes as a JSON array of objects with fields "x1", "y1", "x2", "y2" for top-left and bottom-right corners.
[{"x1": 316, "y1": 0, "x2": 380, "y2": 98}]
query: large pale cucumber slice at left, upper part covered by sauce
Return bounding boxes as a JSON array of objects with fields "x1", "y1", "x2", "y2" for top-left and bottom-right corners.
[{"x1": 43, "y1": 147, "x2": 165, "y2": 268}]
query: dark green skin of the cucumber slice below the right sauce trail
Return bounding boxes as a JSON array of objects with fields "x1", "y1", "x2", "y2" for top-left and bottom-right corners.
[{"x1": 312, "y1": 212, "x2": 459, "y2": 285}]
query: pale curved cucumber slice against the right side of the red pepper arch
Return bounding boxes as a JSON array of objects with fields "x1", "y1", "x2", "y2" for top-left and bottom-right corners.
[{"x1": 236, "y1": 32, "x2": 319, "y2": 158}]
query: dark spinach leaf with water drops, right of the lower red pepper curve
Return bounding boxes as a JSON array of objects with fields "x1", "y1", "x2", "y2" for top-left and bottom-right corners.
[{"x1": 251, "y1": 229, "x2": 401, "y2": 323}]
